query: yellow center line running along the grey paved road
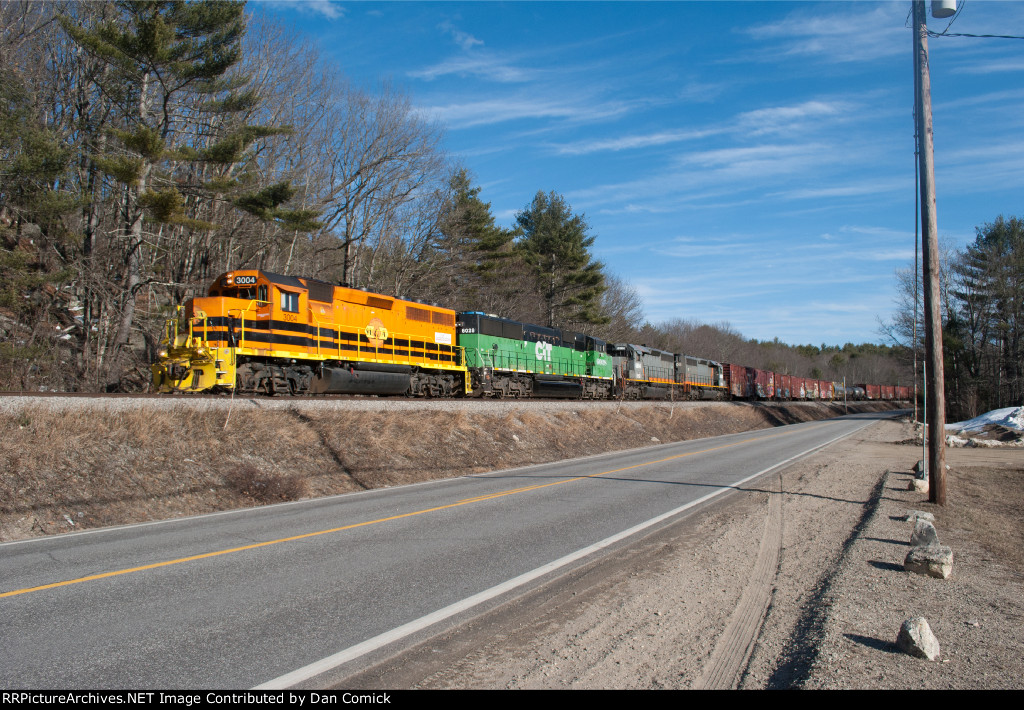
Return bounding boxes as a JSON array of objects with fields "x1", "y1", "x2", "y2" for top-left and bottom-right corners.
[{"x1": 0, "y1": 424, "x2": 822, "y2": 599}]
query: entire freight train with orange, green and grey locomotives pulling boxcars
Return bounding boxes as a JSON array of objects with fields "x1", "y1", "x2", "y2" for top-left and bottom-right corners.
[{"x1": 152, "y1": 269, "x2": 910, "y2": 401}]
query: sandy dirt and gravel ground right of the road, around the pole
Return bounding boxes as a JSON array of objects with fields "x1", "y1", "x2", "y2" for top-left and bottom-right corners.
[{"x1": 351, "y1": 421, "x2": 1024, "y2": 690}]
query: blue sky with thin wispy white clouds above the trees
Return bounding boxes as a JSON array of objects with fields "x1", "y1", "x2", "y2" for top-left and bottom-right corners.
[{"x1": 249, "y1": 0, "x2": 1024, "y2": 344}]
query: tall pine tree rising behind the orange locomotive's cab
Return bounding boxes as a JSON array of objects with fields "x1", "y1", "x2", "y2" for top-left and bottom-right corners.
[{"x1": 61, "y1": 0, "x2": 317, "y2": 380}]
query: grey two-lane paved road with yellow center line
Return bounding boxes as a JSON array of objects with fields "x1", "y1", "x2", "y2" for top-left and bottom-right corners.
[{"x1": 0, "y1": 413, "x2": 892, "y2": 688}]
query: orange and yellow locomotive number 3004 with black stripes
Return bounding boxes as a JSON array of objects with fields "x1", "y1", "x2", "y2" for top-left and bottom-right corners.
[{"x1": 153, "y1": 269, "x2": 469, "y2": 396}]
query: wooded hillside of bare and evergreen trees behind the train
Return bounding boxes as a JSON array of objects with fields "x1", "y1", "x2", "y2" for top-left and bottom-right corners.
[{"x1": 0, "y1": 0, "x2": 909, "y2": 390}]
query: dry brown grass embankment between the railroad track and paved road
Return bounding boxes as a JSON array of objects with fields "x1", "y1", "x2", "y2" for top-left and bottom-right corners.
[{"x1": 0, "y1": 403, "x2": 897, "y2": 540}]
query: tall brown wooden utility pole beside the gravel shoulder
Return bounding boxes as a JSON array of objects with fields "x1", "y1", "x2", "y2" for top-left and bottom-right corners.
[{"x1": 913, "y1": 0, "x2": 946, "y2": 505}]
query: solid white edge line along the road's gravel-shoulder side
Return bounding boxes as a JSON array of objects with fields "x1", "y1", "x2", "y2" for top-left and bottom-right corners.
[{"x1": 252, "y1": 421, "x2": 874, "y2": 691}]
